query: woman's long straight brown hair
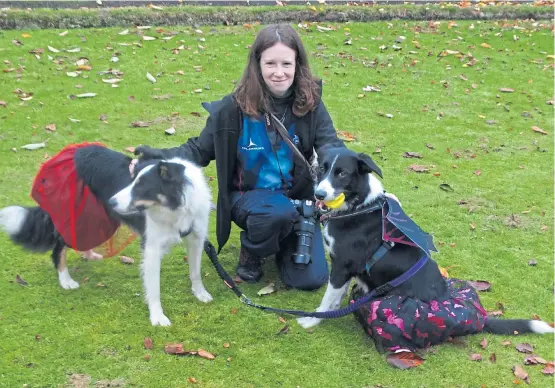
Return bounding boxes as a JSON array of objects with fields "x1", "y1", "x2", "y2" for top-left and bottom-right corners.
[{"x1": 234, "y1": 24, "x2": 320, "y2": 117}]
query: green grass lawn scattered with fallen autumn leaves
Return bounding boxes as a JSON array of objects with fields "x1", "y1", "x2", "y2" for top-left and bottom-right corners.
[{"x1": 0, "y1": 21, "x2": 554, "y2": 387}]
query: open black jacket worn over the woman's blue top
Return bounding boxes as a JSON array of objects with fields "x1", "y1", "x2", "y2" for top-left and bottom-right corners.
[{"x1": 150, "y1": 90, "x2": 344, "y2": 251}]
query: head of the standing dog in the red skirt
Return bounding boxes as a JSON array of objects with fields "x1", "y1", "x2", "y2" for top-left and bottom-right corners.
[{"x1": 110, "y1": 160, "x2": 190, "y2": 214}]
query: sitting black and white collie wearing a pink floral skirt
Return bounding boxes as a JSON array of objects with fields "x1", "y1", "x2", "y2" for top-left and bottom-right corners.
[{"x1": 298, "y1": 148, "x2": 553, "y2": 350}]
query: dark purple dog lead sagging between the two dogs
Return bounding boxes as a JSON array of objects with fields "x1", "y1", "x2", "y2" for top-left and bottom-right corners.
[{"x1": 204, "y1": 240, "x2": 429, "y2": 319}]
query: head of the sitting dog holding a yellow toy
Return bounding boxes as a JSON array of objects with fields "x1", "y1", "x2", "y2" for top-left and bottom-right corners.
[{"x1": 314, "y1": 148, "x2": 384, "y2": 207}]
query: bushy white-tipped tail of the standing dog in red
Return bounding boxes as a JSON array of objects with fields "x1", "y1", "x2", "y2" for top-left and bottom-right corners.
[{"x1": 0, "y1": 206, "x2": 59, "y2": 252}]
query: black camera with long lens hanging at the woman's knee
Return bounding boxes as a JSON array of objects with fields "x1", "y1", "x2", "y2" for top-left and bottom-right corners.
[{"x1": 291, "y1": 199, "x2": 317, "y2": 267}]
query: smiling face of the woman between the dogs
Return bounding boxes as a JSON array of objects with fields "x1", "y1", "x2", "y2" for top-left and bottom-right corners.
[{"x1": 260, "y1": 43, "x2": 296, "y2": 97}]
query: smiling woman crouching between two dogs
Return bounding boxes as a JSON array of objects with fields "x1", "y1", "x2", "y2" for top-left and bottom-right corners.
[{"x1": 135, "y1": 24, "x2": 344, "y2": 290}]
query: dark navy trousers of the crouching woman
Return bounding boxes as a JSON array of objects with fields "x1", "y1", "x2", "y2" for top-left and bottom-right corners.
[{"x1": 231, "y1": 189, "x2": 329, "y2": 290}]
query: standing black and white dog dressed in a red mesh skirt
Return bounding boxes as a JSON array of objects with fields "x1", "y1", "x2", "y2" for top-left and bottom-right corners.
[{"x1": 0, "y1": 145, "x2": 212, "y2": 326}]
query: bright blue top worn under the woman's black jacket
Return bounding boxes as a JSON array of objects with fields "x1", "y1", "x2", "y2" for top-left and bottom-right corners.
[{"x1": 234, "y1": 116, "x2": 299, "y2": 191}]
